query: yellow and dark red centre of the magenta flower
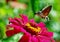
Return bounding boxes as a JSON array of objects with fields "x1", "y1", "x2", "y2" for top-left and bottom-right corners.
[{"x1": 25, "y1": 23, "x2": 41, "y2": 34}]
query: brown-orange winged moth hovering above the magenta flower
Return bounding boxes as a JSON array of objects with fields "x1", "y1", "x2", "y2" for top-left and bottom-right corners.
[{"x1": 35, "y1": 6, "x2": 52, "y2": 19}]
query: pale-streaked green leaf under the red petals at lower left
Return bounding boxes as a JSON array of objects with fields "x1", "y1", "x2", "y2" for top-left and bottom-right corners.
[{"x1": 0, "y1": 33, "x2": 23, "y2": 42}]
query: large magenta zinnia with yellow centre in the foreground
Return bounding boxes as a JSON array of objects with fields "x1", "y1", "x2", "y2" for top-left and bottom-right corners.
[{"x1": 6, "y1": 15, "x2": 55, "y2": 42}]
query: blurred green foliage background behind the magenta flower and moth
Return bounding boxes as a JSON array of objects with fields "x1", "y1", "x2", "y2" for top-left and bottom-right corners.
[{"x1": 0, "y1": 0, "x2": 60, "y2": 42}]
